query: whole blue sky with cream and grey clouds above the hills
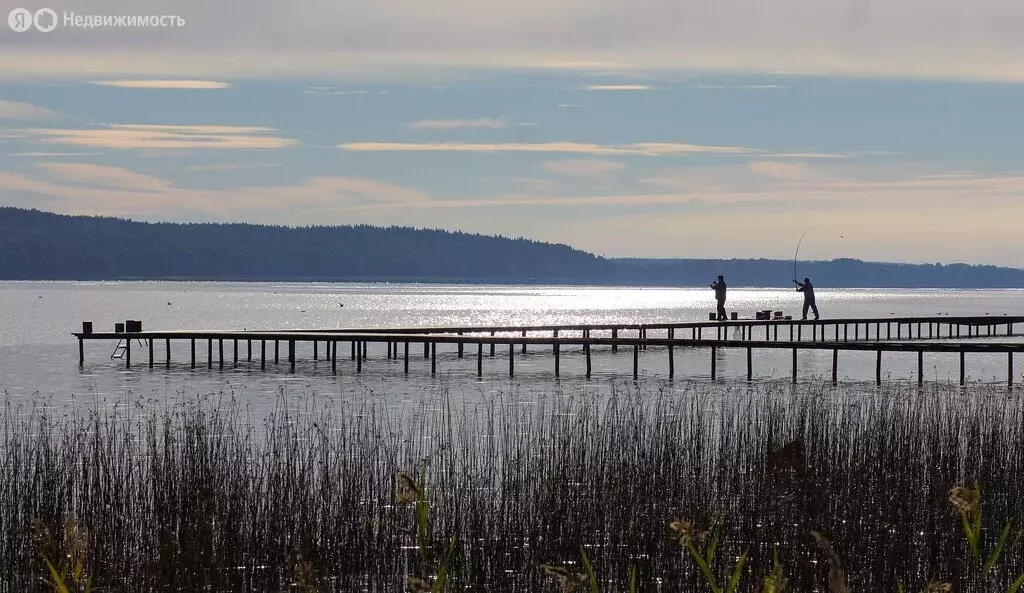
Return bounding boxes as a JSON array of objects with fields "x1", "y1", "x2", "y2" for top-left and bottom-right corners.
[{"x1": 0, "y1": 0, "x2": 1024, "y2": 268}]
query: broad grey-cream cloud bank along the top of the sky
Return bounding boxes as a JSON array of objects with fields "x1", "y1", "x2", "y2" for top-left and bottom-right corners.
[{"x1": 6, "y1": 0, "x2": 1024, "y2": 81}]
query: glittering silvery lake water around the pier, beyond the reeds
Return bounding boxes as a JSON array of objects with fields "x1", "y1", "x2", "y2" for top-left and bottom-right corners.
[{"x1": 0, "y1": 282, "x2": 1024, "y2": 417}]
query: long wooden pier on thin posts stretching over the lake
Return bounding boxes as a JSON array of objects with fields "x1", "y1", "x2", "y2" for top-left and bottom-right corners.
[{"x1": 74, "y1": 315, "x2": 1024, "y2": 387}]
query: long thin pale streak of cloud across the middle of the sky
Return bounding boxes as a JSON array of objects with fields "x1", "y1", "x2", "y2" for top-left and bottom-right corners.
[{"x1": 338, "y1": 142, "x2": 760, "y2": 157}]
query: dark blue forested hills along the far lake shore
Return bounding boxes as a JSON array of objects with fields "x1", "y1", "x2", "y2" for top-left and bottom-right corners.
[{"x1": 0, "y1": 208, "x2": 1024, "y2": 288}]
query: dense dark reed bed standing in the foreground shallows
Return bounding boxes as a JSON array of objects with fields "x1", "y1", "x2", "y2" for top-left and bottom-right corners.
[{"x1": 0, "y1": 382, "x2": 1024, "y2": 593}]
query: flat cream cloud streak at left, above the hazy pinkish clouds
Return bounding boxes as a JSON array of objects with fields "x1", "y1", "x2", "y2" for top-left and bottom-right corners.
[{"x1": 24, "y1": 124, "x2": 298, "y2": 150}]
